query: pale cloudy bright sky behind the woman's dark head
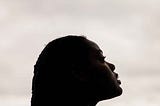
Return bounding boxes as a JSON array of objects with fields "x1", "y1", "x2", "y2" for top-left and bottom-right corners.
[{"x1": 0, "y1": 0, "x2": 160, "y2": 106}]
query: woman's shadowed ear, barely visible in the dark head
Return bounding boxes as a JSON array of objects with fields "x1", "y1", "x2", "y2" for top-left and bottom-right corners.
[{"x1": 72, "y1": 65, "x2": 90, "y2": 82}]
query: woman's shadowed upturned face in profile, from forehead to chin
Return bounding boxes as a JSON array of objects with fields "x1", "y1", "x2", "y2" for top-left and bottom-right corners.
[{"x1": 79, "y1": 40, "x2": 122, "y2": 101}]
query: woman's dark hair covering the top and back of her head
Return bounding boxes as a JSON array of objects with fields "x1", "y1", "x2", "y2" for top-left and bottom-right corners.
[{"x1": 31, "y1": 35, "x2": 93, "y2": 106}]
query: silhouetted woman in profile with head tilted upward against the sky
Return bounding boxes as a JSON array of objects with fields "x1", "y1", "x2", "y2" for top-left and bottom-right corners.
[{"x1": 31, "y1": 36, "x2": 122, "y2": 106}]
